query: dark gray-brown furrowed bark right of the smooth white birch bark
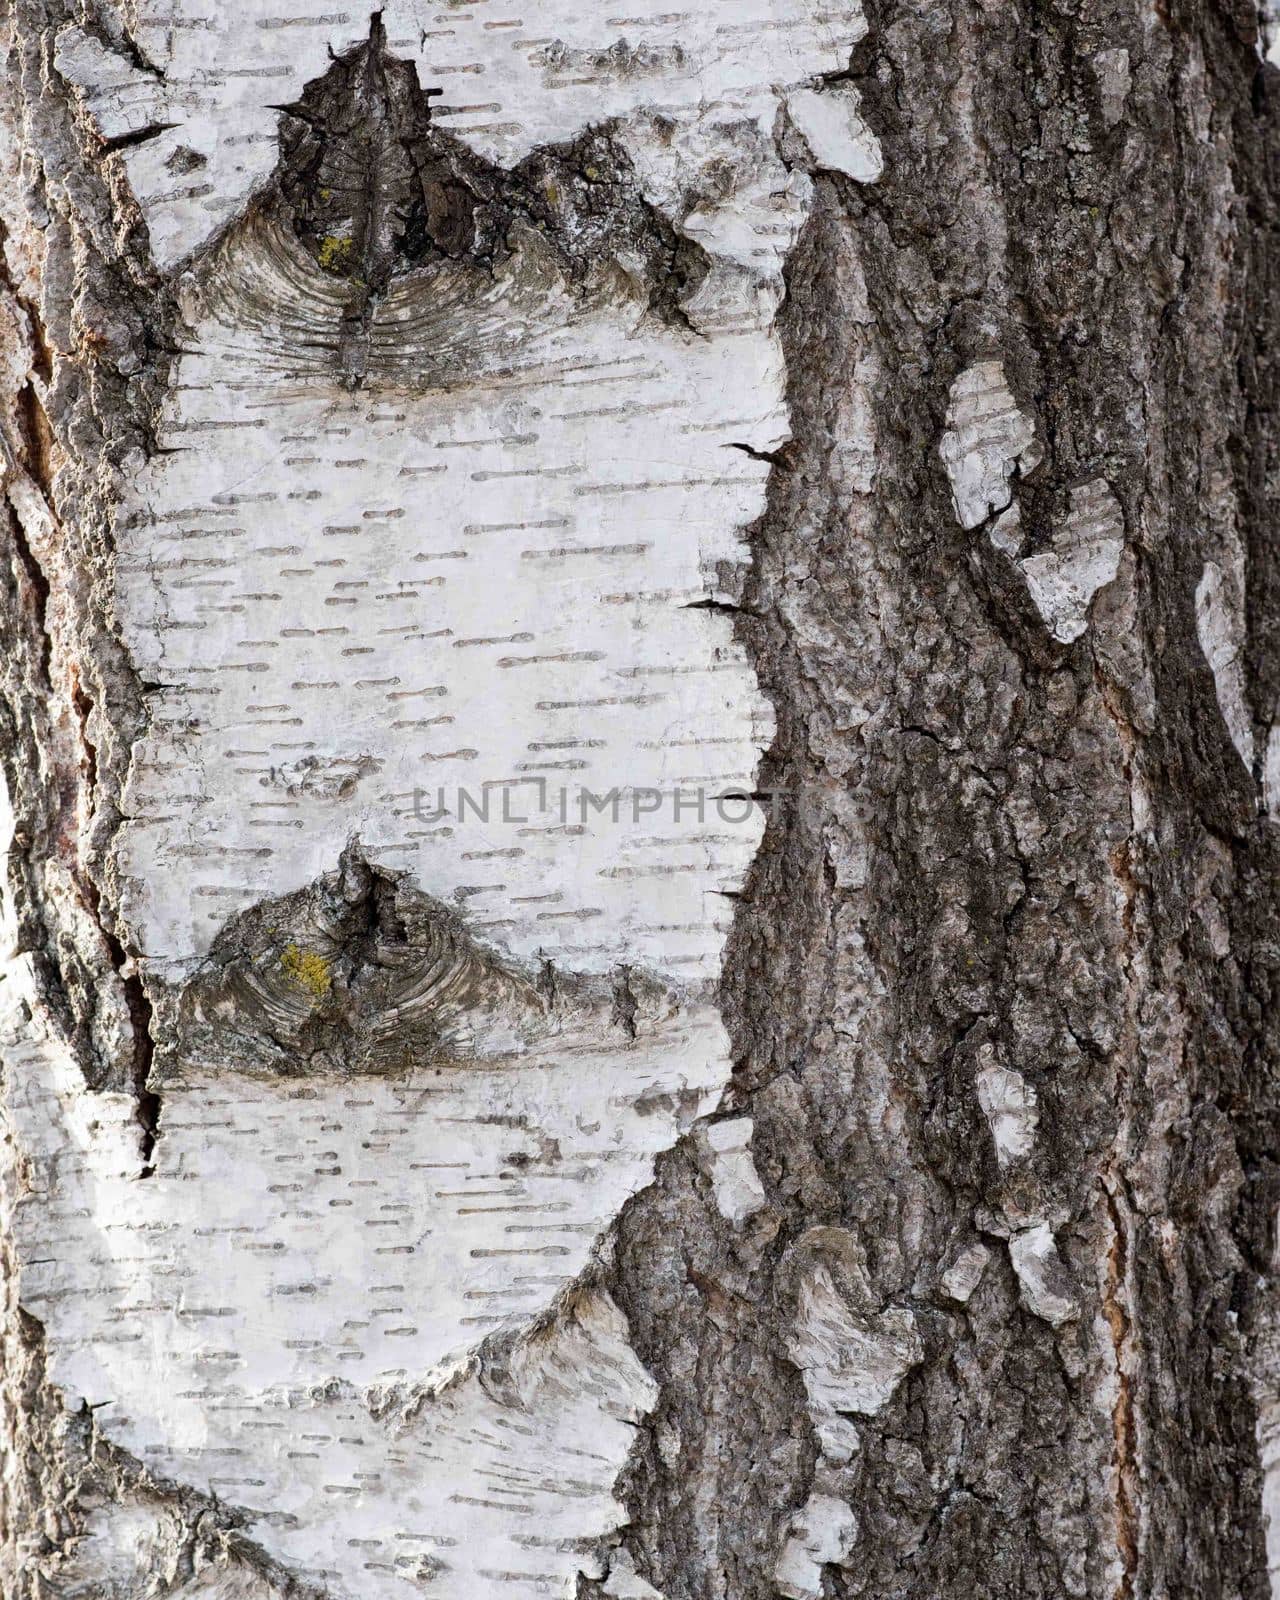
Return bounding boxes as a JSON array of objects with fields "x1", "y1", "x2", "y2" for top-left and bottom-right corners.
[{"x1": 604, "y1": 5, "x2": 1277, "y2": 1600}]
